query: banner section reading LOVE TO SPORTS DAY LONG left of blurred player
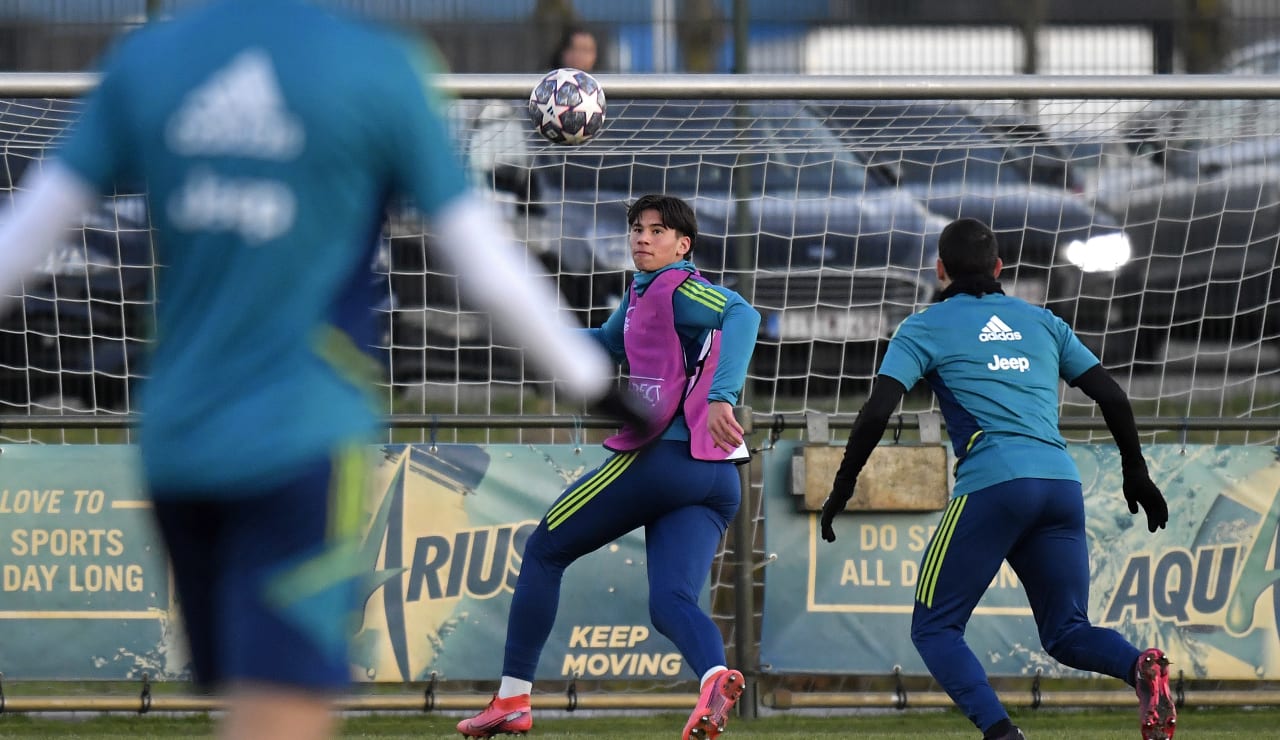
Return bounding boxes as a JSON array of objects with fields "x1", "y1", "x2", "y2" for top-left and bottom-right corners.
[{"x1": 0, "y1": 444, "x2": 175, "y2": 679}]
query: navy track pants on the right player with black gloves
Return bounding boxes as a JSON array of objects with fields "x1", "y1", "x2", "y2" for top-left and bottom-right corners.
[{"x1": 911, "y1": 478, "x2": 1139, "y2": 731}]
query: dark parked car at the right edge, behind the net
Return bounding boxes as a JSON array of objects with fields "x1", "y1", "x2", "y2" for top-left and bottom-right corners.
[{"x1": 1100, "y1": 100, "x2": 1280, "y2": 356}]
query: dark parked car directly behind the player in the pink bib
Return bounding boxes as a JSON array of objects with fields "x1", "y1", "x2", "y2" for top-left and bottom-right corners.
[{"x1": 524, "y1": 101, "x2": 946, "y2": 379}]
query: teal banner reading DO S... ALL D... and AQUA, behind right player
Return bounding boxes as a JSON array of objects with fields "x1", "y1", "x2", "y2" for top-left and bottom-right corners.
[{"x1": 760, "y1": 442, "x2": 1280, "y2": 679}]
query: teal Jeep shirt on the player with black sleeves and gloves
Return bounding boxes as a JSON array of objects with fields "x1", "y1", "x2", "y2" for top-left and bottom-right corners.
[{"x1": 879, "y1": 293, "x2": 1098, "y2": 495}]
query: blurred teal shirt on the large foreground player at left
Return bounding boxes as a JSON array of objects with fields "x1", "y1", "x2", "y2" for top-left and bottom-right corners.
[{"x1": 59, "y1": 0, "x2": 463, "y2": 495}]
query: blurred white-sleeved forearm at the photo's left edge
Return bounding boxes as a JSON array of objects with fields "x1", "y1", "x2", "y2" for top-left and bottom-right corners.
[{"x1": 0, "y1": 161, "x2": 95, "y2": 305}]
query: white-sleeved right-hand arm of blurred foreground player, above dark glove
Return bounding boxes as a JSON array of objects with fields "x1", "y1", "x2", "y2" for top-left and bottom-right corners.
[{"x1": 436, "y1": 189, "x2": 613, "y2": 398}]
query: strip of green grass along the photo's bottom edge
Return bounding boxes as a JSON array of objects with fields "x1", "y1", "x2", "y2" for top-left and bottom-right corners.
[{"x1": 0, "y1": 708, "x2": 1280, "y2": 740}]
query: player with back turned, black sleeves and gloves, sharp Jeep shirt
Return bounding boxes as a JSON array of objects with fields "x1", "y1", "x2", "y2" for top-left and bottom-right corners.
[{"x1": 820, "y1": 219, "x2": 1175, "y2": 740}]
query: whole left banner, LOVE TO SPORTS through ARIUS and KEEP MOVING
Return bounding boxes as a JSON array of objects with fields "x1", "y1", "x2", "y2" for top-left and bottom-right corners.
[{"x1": 0, "y1": 444, "x2": 705, "y2": 681}]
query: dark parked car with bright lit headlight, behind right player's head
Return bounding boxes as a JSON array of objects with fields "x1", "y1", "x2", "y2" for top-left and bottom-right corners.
[{"x1": 814, "y1": 101, "x2": 1137, "y2": 365}]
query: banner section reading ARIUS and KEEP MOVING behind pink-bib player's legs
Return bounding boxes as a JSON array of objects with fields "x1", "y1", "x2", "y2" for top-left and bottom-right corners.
[{"x1": 355, "y1": 444, "x2": 692, "y2": 681}]
